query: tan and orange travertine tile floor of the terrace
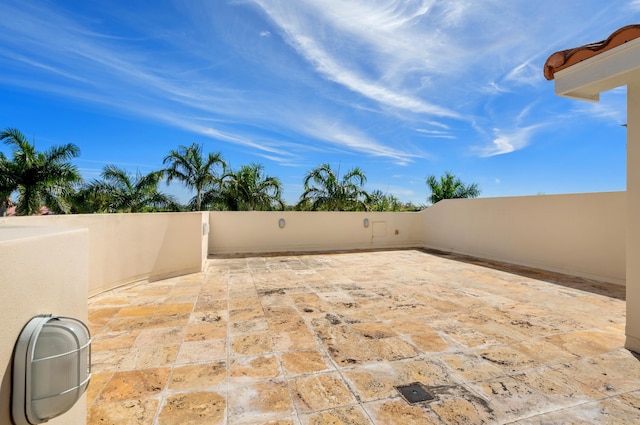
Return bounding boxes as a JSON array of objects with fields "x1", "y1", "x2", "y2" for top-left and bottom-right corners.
[{"x1": 87, "y1": 250, "x2": 640, "y2": 425}]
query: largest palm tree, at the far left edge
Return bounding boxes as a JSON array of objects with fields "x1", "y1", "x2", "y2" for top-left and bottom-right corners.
[{"x1": 0, "y1": 128, "x2": 82, "y2": 215}]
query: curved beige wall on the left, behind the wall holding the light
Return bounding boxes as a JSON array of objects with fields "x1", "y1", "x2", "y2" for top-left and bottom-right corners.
[{"x1": 0, "y1": 212, "x2": 209, "y2": 295}]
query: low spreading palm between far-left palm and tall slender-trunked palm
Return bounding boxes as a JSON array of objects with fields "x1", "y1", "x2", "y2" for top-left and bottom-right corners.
[{"x1": 91, "y1": 165, "x2": 178, "y2": 213}]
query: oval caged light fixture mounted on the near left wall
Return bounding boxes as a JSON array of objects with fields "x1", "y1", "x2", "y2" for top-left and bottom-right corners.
[{"x1": 11, "y1": 314, "x2": 91, "y2": 425}]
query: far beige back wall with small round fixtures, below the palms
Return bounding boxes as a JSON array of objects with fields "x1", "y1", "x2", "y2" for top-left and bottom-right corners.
[{"x1": 209, "y1": 211, "x2": 422, "y2": 254}]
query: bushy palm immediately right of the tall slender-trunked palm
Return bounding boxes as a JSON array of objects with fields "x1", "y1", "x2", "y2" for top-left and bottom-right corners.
[{"x1": 222, "y1": 164, "x2": 284, "y2": 211}]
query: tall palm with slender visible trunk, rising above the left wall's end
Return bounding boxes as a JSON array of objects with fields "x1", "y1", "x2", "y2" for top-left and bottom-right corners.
[{"x1": 162, "y1": 143, "x2": 226, "y2": 211}]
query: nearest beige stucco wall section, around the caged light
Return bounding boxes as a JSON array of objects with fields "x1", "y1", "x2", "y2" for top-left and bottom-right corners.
[{"x1": 0, "y1": 226, "x2": 89, "y2": 425}]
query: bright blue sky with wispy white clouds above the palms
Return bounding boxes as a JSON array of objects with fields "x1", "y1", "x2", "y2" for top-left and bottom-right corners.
[{"x1": 0, "y1": 0, "x2": 640, "y2": 204}]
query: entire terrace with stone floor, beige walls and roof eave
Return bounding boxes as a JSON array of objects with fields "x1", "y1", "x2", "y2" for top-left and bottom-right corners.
[{"x1": 0, "y1": 23, "x2": 640, "y2": 425}]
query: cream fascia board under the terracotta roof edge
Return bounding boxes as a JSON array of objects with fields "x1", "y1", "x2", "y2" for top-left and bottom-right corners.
[{"x1": 554, "y1": 38, "x2": 640, "y2": 102}]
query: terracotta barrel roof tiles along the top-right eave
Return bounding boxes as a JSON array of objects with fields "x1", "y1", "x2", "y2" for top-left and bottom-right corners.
[{"x1": 544, "y1": 24, "x2": 640, "y2": 80}]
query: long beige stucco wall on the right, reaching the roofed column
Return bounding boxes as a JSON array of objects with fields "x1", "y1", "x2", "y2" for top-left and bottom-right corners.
[{"x1": 423, "y1": 192, "x2": 626, "y2": 284}]
